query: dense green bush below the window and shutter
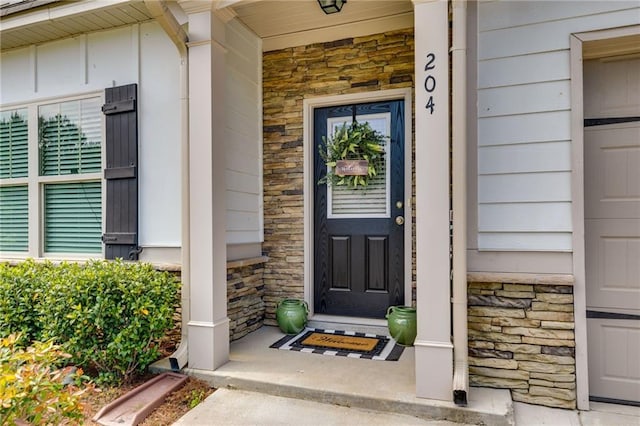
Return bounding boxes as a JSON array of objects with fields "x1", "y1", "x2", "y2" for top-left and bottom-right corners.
[{"x1": 0, "y1": 260, "x2": 179, "y2": 384}]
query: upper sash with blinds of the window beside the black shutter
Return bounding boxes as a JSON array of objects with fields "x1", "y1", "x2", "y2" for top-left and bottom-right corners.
[{"x1": 38, "y1": 98, "x2": 102, "y2": 176}]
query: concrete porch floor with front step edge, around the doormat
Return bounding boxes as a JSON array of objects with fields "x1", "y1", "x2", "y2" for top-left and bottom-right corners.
[{"x1": 176, "y1": 326, "x2": 514, "y2": 425}]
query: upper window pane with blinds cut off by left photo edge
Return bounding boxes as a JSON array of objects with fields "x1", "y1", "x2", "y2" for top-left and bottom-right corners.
[{"x1": 0, "y1": 109, "x2": 29, "y2": 179}]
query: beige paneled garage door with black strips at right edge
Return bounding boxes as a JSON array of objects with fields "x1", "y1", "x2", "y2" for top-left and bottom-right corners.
[{"x1": 584, "y1": 56, "x2": 640, "y2": 405}]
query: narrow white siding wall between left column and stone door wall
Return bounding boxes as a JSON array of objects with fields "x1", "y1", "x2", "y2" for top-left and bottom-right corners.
[{"x1": 225, "y1": 20, "x2": 263, "y2": 246}]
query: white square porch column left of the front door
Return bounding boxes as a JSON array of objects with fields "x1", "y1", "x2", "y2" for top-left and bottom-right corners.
[{"x1": 186, "y1": 8, "x2": 229, "y2": 370}]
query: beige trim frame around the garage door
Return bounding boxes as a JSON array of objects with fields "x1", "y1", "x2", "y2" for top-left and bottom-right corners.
[{"x1": 570, "y1": 25, "x2": 640, "y2": 410}]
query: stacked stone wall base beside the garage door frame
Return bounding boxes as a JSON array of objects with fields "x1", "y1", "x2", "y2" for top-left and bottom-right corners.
[{"x1": 468, "y1": 282, "x2": 576, "y2": 409}]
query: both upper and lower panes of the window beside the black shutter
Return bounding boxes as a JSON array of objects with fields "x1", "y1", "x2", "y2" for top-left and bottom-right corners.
[{"x1": 38, "y1": 97, "x2": 102, "y2": 253}]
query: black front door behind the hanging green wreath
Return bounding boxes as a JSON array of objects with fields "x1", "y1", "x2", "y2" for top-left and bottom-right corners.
[{"x1": 314, "y1": 100, "x2": 408, "y2": 318}]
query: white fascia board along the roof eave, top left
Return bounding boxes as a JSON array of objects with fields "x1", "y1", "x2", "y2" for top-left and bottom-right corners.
[{"x1": 0, "y1": 0, "x2": 131, "y2": 32}]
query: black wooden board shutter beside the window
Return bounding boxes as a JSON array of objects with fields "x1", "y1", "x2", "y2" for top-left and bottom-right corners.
[{"x1": 102, "y1": 84, "x2": 141, "y2": 260}]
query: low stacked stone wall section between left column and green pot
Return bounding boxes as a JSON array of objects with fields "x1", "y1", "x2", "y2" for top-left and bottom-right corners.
[{"x1": 227, "y1": 263, "x2": 264, "y2": 341}]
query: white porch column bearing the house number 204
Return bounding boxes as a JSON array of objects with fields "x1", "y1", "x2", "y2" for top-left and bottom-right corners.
[{"x1": 413, "y1": 0, "x2": 453, "y2": 401}]
